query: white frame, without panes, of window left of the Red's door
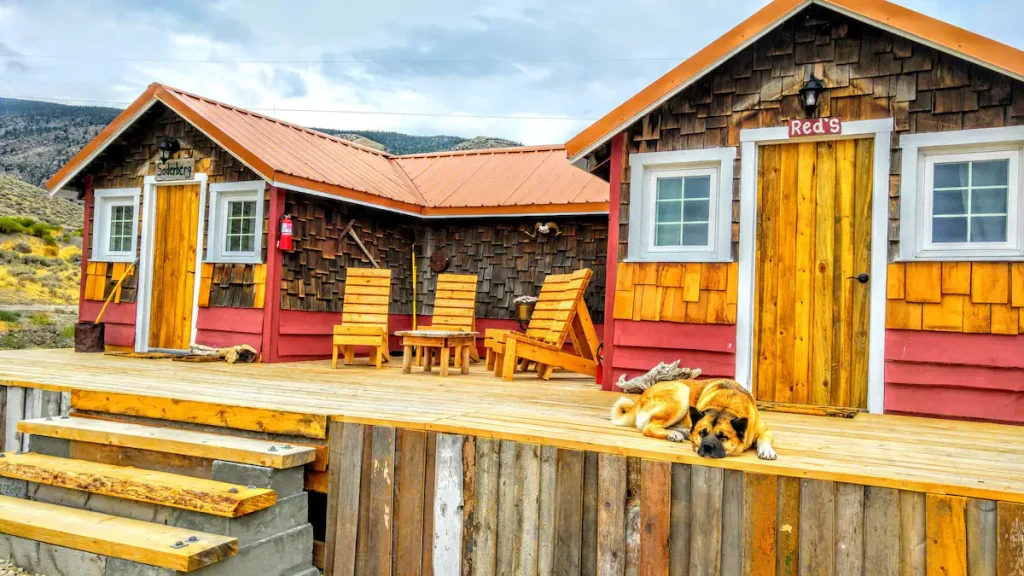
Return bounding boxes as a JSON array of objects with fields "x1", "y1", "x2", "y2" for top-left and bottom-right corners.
[{"x1": 626, "y1": 148, "x2": 736, "y2": 262}]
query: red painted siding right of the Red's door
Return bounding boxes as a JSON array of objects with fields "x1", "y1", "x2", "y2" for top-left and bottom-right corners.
[{"x1": 885, "y1": 330, "x2": 1024, "y2": 423}]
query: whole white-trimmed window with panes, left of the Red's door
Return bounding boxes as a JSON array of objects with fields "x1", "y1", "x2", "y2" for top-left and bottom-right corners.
[{"x1": 628, "y1": 148, "x2": 736, "y2": 262}]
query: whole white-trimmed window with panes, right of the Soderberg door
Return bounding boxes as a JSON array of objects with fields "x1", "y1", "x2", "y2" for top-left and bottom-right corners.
[{"x1": 206, "y1": 180, "x2": 266, "y2": 263}]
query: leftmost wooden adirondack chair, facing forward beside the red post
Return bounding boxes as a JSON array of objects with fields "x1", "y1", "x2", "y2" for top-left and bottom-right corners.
[{"x1": 331, "y1": 269, "x2": 391, "y2": 368}]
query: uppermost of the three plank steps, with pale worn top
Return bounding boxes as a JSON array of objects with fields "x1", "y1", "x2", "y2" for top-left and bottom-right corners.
[{"x1": 17, "y1": 416, "x2": 316, "y2": 469}]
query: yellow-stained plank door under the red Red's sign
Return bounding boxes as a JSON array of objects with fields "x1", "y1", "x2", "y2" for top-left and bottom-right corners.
[{"x1": 754, "y1": 139, "x2": 873, "y2": 408}]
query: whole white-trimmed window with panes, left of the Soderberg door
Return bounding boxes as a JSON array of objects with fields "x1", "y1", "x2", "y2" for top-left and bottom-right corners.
[{"x1": 92, "y1": 188, "x2": 141, "y2": 262}]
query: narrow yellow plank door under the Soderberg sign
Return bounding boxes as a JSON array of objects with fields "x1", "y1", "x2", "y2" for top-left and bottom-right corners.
[{"x1": 150, "y1": 184, "x2": 199, "y2": 349}]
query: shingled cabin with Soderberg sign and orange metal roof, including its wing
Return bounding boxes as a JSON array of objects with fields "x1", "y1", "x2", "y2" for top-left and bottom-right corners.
[{"x1": 48, "y1": 84, "x2": 607, "y2": 362}]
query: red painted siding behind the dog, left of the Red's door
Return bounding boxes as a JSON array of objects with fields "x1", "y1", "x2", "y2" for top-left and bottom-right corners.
[{"x1": 604, "y1": 320, "x2": 736, "y2": 389}]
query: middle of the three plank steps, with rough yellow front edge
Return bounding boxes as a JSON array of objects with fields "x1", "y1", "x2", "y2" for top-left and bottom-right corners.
[{"x1": 0, "y1": 452, "x2": 278, "y2": 518}]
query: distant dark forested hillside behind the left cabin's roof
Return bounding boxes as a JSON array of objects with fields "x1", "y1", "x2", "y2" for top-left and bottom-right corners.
[{"x1": 0, "y1": 94, "x2": 521, "y2": 183}]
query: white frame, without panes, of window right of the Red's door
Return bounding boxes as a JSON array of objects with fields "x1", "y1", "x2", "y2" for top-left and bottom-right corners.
[{"x1": 899, "y1": 127, "x2": 1024, "y2": 261}]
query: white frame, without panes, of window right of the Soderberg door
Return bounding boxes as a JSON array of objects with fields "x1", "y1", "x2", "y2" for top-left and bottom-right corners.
[{"x1": 204, "y1": 180, "x2": 266, "y2": 264}]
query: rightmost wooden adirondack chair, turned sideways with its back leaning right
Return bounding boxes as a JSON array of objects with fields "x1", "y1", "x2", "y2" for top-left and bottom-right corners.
[{"x1": 492, "y1": 269, "x2": 599, "y2": 380}]
